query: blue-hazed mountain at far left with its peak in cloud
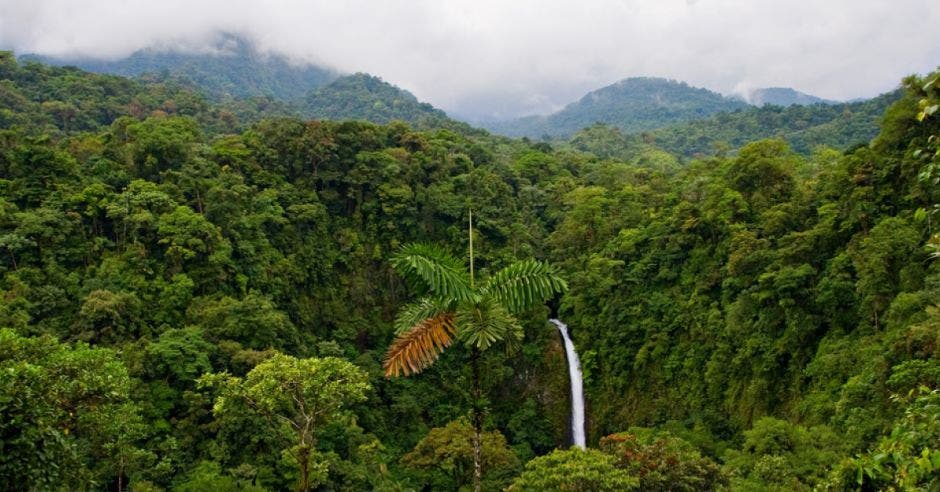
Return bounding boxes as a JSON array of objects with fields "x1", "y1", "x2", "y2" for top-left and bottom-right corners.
[{"x1": 21, "y1": 34, "x2": 339, "y2": 101}]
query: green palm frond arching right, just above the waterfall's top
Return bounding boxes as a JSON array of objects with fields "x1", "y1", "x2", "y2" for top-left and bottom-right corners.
[{"x1": 481, "y1": 260, "x2": 568, "y2": 313}]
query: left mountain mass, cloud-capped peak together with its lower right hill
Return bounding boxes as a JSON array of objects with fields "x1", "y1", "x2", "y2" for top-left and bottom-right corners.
[{"x1": 20, "y1": 35, "x2": 482, "y2": 131}]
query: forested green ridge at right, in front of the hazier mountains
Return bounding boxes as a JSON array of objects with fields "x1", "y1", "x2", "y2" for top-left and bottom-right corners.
[{"x1": 645, "y1": 91, "x2": 901, "y2": 157}]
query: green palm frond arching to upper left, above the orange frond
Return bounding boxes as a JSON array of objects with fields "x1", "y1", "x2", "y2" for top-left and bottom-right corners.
[{"x1": 392, "y1": 243, "x2": 477, "y2": 302}]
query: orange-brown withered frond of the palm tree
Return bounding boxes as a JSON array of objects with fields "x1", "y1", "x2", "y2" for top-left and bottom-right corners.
[{"x1": 382, "y1": 312, "x2": 455, "y2": 377}]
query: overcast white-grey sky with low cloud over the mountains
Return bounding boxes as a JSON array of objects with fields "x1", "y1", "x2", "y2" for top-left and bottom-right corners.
[{"x1": 0, "y1": 0, "x2": 940, "y2": 117}]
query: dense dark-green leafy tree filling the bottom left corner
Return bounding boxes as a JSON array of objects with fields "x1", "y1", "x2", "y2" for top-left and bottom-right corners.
[{"x1": 0, "y1": 329, "x2": 153, "y2": 490}]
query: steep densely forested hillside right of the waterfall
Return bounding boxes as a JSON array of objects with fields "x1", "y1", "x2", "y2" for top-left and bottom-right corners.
[{"x1": 549, "y1": 70, "x2": 937, "y2": 466}]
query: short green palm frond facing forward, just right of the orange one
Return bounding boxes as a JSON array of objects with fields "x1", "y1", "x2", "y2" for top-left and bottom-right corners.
[{"x1": 454, "y1": 298, "x2": 523, "y2": 350}]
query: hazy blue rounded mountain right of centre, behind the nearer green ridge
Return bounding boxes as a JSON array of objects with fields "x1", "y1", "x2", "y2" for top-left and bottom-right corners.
[{"x1": 484, "y1": 77, "x2": 748, "y2": 138}]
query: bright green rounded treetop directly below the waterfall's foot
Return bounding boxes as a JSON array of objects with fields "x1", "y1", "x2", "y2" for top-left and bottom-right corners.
[{"x1": 507, "y1": 448, "x2": 639, "y2": 492}]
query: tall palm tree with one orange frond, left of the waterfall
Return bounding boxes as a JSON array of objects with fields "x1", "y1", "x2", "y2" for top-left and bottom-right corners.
[{"x1": 383, "y1": 226, "x2": 567, "y2": 492}]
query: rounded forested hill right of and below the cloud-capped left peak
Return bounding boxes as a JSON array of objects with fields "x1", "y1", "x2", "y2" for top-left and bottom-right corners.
[{"x1": 300, "y1": 73, "x2": 453, "y2": 127}]
